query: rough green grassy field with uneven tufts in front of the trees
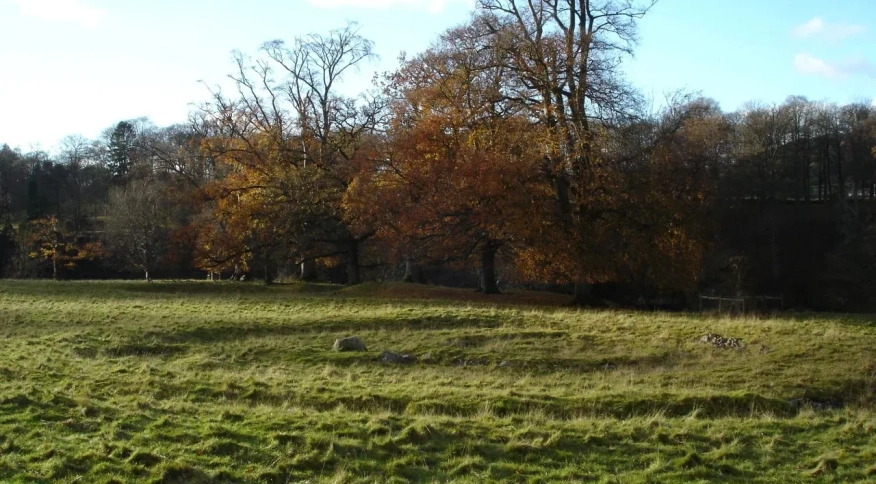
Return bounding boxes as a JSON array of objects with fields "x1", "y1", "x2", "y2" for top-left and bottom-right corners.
[{"x1": 0, "y1": 281, "x2": 876, "y2": 483}]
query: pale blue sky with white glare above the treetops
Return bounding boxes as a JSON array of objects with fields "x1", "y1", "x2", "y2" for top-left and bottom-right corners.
[{"x1": 0, "y1": 0, "x2": 876, "y2": 151}]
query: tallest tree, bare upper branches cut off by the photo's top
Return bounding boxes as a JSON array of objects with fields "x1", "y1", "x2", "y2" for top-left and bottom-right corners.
[{"x1": 479, "y1": 0, "x2": 720, "y2": 304}]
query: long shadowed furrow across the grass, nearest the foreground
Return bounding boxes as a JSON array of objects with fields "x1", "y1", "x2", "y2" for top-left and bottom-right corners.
[{"x1": 164, "y1": 378, "x2": 840, "y2": 420}]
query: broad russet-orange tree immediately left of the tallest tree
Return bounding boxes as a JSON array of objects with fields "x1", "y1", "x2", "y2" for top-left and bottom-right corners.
[{"x1": 347, "y1": 19, "x2": 537, "y2": 294}]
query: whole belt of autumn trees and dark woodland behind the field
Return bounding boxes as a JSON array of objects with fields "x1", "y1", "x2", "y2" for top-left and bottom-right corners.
[{"x1": 0, "y1": 0, "x2": 876, "y2": 311}]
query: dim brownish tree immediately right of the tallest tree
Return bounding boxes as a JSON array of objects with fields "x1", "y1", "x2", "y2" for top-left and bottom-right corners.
[{"x1": 604, "y1": 95, "x2": 732, "y2": 291}]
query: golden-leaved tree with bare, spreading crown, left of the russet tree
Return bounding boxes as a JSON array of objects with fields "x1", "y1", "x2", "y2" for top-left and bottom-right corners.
[{"x1": 203, "y1": 24, "x2": 382, "y2": 284}]
